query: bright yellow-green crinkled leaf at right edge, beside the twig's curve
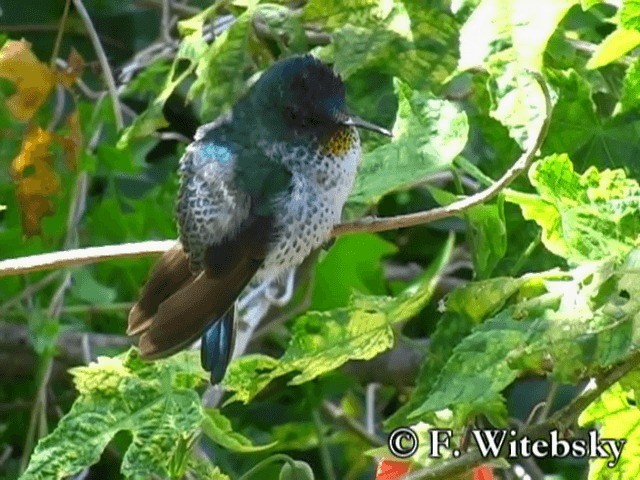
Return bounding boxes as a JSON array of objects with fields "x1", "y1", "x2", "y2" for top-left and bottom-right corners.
[{"x1": 506, "y1": 155, "x2": 640, "y2": 262}]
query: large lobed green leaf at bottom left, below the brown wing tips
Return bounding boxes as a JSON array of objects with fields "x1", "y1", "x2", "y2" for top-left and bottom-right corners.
[{"x1": 21, "y1": 349, "x2": 206, "y2": 480}]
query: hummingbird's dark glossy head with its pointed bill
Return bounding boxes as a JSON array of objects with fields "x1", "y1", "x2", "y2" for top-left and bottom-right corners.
[{"x1": 251, "y1": 55, "x2": 390, "y2": 141}]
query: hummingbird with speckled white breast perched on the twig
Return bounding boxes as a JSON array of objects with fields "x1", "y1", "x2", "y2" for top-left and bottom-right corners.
[{"x1": 127, "y1": 55, "x2": 391, "y2": 384}]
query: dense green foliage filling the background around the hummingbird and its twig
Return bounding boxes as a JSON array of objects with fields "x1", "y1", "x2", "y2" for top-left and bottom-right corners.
[{"x1": 0, "y1": 0, "x2": 640, "y2": 479}]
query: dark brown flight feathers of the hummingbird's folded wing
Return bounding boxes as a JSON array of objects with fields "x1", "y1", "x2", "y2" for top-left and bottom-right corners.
[{"x1": 129, "y1": 217, "x2": 271, "y2": 360}]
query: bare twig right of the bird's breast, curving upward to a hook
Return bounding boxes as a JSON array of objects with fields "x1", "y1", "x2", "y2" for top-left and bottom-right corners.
[{"x1": 333, "y1": 72, "x2": 552, "y2": 237}]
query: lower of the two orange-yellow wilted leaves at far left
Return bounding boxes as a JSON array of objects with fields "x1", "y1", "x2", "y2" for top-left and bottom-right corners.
[{"x1": 11, "y1": 127, "x2": 60, "y2": 235}]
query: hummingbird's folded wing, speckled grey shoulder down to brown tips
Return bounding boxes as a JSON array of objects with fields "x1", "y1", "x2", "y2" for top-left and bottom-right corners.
[{"x1": 128, "y1": 120, "x2": 284, "y2": 359}]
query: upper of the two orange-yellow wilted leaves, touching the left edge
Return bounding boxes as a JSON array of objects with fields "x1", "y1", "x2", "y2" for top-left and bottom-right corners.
[{"x1": 0, "y1": 40, "x2": 55, "y2": 122}]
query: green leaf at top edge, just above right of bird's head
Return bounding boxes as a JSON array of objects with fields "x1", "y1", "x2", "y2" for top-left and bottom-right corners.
[{"x1": 304, "y1": 0, "x2": 458, "y2": 89}]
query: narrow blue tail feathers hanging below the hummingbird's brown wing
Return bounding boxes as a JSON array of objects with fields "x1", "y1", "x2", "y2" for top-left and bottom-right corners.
[{"x1": 200, "y1": 307, "x2": 235, "y2": 385}]
